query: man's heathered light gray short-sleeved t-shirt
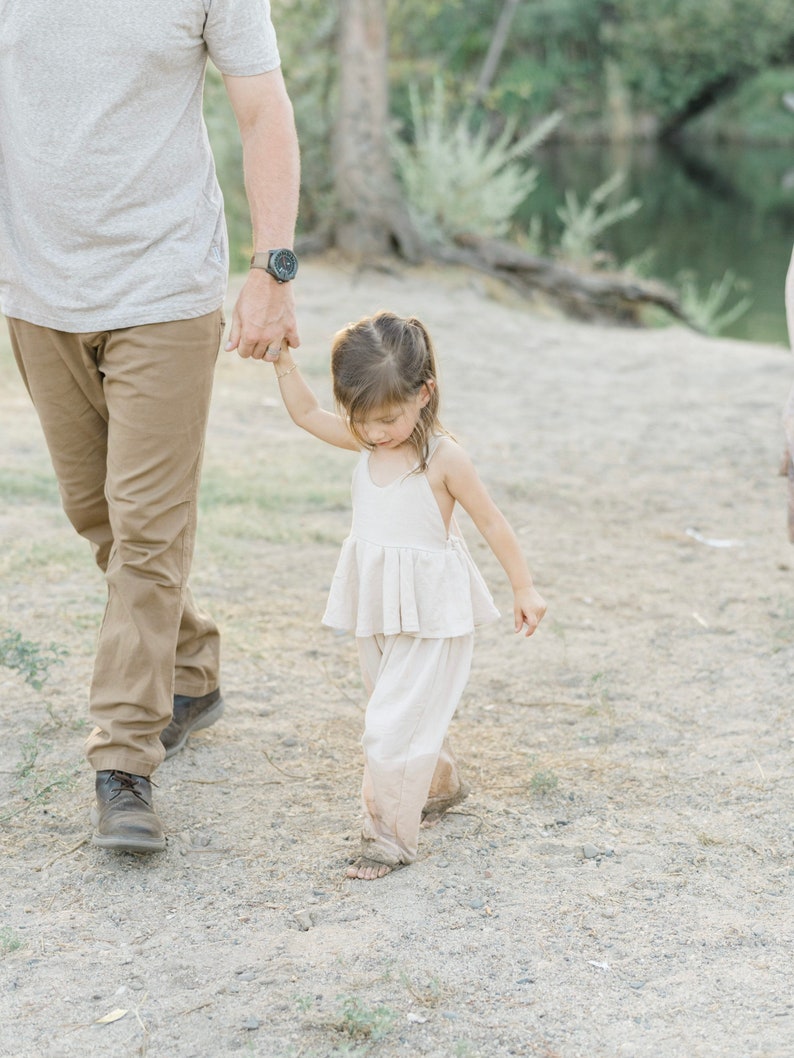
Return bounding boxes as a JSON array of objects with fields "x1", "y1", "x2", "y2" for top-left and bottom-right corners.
[{"x1": 0, "y1": 0, "x2": 279, "y2": 332}]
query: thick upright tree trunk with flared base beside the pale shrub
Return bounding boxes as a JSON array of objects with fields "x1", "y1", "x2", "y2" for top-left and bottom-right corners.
[{"x1": 333, "y1": 0, "x2": 417, "y2": 261}]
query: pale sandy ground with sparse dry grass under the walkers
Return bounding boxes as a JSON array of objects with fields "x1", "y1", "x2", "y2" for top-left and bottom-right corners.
[{"x1": 0, "y1": 262, "x2": 794, "y2": 1058}]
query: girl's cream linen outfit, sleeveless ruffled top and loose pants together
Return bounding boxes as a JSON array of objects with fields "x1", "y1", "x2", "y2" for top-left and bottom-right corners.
[{"x1": 323, "y1": 436, "x2": 499, "y2": 865}]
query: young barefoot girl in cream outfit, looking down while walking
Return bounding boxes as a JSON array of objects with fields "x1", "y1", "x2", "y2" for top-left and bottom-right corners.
[{"x1": 267, "y1": 312, "x2": 546, "y2": 880}]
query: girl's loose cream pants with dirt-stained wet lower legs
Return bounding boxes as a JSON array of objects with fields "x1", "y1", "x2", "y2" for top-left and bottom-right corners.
[{"x1": 357, "y1": 635, "x2": 474, "y2": 865}]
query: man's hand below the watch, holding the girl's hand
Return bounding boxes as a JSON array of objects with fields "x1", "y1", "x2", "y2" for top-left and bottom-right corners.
[{"x1": 225, "y1": 269, "x2": 301, "y2": 363}]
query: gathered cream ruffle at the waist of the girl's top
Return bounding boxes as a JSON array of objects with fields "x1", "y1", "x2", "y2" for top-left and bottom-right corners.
[{"x1": 323, "y1": 536, "x2": 500, "y2": 639}]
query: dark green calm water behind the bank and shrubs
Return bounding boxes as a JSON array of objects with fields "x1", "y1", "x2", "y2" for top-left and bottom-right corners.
[{"x1": 526, "y1": 144, "x2": 794, "y2": 345}]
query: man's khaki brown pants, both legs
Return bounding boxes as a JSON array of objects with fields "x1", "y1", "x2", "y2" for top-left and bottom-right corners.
[{"x1": 7, "y1": 310, "x2": 223, "y2": 776}]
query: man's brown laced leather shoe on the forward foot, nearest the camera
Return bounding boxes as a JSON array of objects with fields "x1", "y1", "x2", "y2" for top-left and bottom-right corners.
[{"x1": 91, "y1": 771, "x2": 165, "y2": 853}]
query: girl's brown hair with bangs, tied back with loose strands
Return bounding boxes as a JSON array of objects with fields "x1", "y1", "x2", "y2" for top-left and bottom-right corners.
[{"x1": 331, "y1": 312, "x2": 446, "y2": 472}]
